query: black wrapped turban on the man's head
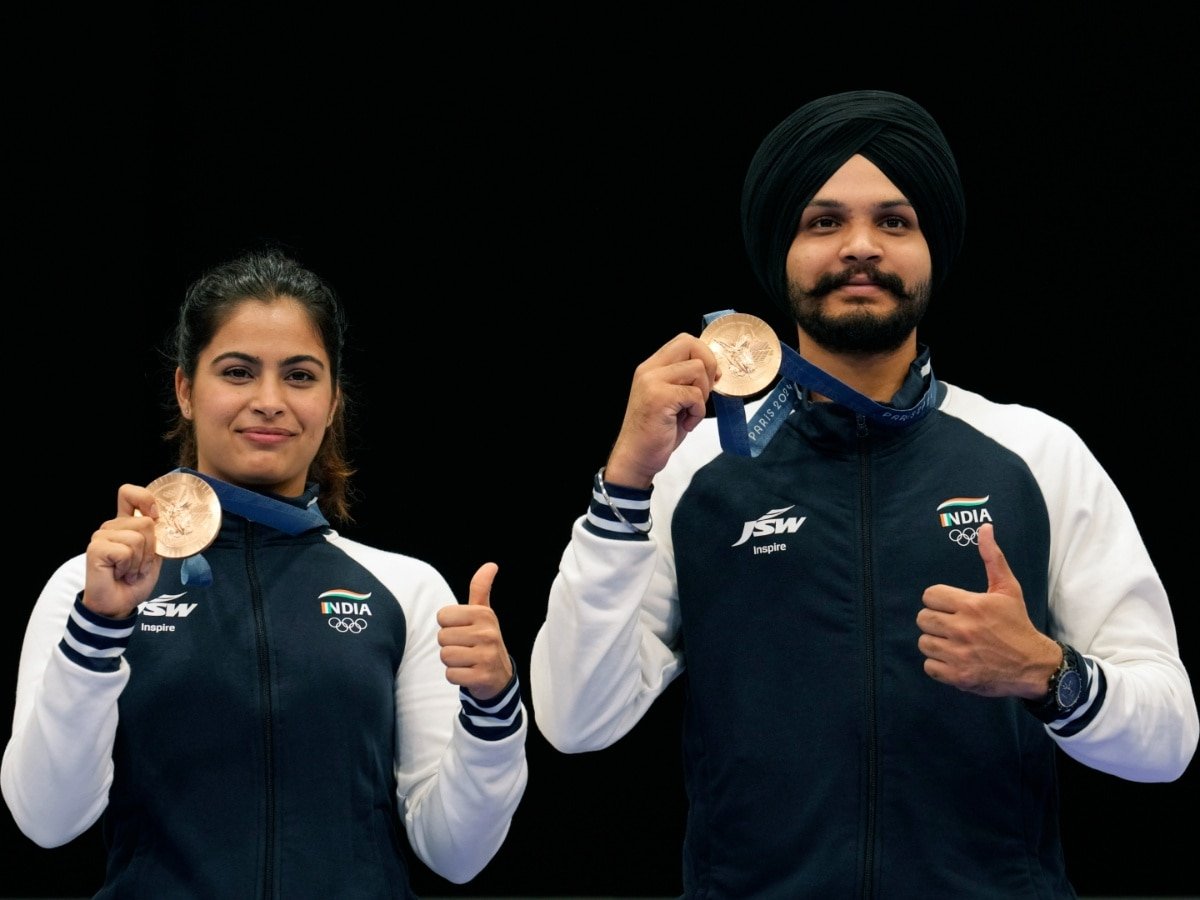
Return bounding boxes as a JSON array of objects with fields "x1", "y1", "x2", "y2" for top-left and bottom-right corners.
[{"x1": 742, "y1": 90, "x2": 966, "y2": 313}]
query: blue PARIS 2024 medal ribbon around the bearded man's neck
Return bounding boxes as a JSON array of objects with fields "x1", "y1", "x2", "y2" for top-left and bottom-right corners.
[{"x1": 703, "y1": 310, "x2": 937, "y2": 456}]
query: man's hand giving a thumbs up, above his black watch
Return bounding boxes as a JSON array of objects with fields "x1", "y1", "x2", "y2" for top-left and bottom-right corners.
[{"x1": 917, "y1": 524, "x2": 1062, "y2": 700}]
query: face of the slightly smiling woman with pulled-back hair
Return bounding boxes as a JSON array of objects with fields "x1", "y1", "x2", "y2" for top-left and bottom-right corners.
[{"x1": 175, "y1": 298, "x2": 338, "y2": 497}]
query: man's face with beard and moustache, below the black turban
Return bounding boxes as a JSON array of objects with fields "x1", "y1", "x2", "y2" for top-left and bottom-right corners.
[{"x1": 787, "y1": 155, "x2": 932, "y2": 354}]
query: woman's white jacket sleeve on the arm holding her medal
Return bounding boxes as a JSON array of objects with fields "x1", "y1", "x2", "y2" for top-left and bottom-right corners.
[{"x1": 0, "y1": 556, "x2": 125, "y2": 847}]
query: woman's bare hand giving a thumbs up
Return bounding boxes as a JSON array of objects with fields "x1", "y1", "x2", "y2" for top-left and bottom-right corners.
[{"x1": 438, "y1": 563, "x2": 512, "y2": 701}]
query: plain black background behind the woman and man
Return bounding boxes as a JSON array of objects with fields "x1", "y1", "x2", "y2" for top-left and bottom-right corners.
[{"x1": 0, "y1": 4, "x2": 1200, "y2": 896}]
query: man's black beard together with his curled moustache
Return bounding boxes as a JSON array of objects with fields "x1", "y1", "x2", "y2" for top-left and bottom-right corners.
[{"x1": 787, "y1": 266, "x2": 932, "y2": 354}]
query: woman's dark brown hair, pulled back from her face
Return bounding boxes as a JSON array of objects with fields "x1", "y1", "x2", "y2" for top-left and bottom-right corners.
[{"x1": 163, "y1": 248, "x2": 354, "y2": 523}]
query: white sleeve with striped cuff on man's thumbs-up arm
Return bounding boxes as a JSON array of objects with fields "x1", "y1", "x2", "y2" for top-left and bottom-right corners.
[{"x1": 942, "y1": 389, "x2": 1200, "y2": 781}]
